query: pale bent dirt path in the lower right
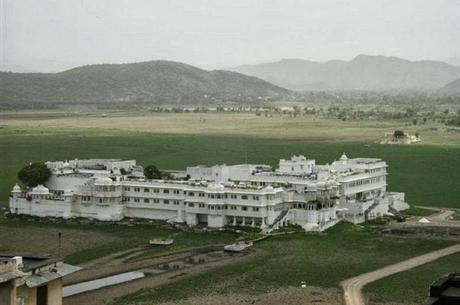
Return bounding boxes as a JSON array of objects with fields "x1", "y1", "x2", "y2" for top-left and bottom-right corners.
[{"x1": 340, "y1": 244, "x2": 460, "y2": 305}]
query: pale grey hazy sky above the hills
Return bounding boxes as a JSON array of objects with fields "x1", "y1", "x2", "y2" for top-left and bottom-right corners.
[{"x1": 0, "y1": 0, "x2": 460, "y2": 71}]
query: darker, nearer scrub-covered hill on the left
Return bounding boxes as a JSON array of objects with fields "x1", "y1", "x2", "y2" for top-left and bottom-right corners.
[{"x1": 0, "y1": 61, "x2": 291, "y2": 104}]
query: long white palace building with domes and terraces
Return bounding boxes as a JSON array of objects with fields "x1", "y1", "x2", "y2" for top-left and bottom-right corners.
[{"x1": 9, "y1": 154, "x2": 409, "y2": 231}]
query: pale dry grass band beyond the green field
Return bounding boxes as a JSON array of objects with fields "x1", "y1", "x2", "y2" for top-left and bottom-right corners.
[{"x1": 2, "y1": 113, "x2": 460, "y2": 144}]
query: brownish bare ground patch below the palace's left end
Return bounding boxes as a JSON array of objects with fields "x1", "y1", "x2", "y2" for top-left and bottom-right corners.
[{"x1": 0, "y1": 226, "x2": 118, "y2": 256}]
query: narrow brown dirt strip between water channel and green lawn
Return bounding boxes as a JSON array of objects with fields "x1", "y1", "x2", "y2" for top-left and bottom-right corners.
[{"x1": 64, "y1": 247, "x2": 263, "y2": 305}]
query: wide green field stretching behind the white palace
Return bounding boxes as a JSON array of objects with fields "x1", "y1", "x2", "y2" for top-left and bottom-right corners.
[{"x1": 0, "y1": 127, "x2": 460, "y2": 207}]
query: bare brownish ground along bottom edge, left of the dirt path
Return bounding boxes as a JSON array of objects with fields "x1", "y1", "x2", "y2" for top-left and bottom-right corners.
[{"x1": 153, "y1": 287, "x2": 342, "y2": 305}]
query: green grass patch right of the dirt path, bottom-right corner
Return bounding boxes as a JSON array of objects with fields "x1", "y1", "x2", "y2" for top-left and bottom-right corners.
[{"x1": 364, "y1": 253, "x2": 460, "y2": 304}]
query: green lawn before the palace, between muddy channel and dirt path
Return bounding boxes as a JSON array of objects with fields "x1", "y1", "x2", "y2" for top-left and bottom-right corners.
[{"x1": 112, "y1": 223, "x2": 452, "y2": 305}]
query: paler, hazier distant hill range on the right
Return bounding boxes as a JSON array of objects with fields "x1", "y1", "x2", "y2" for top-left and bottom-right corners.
[{"x1": 231, "y1": 55, "x2": 460, "y2": 90}]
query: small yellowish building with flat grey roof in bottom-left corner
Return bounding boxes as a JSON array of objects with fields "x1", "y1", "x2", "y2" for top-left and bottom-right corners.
[{"x1": 0, "y1": 253, "x2": 80, "y2": 305}]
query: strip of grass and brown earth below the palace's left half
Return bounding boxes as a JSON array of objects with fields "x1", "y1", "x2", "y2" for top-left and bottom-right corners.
[{"x1": 0, "y1": 217, "x2": 238, "y2": 264}]
